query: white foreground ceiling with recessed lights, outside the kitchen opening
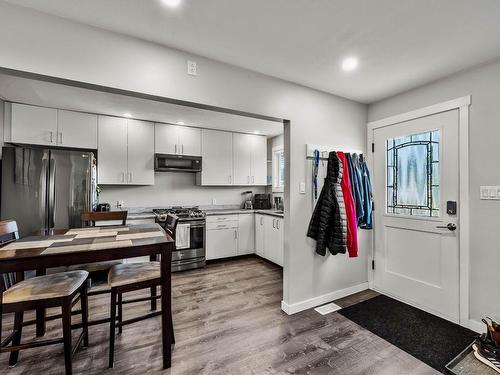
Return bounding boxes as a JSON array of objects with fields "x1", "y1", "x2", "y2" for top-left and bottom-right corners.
[{"x1": 7, "y1": 0, "x2": 500, "y2": 103}]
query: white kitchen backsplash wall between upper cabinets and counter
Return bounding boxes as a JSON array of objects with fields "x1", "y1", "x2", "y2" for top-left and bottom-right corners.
[{"x1": 99, "y1": 173, "x2": 265, "y2": 208}]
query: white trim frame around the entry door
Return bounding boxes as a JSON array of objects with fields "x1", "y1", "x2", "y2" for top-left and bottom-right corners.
[{"x1": 367, "y1": 95, "x2": 474, "y2": 328}]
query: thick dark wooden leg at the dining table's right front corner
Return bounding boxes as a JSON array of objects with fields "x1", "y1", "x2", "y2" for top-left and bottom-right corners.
[{"x1": 160, "y1": 245, "x2": 172, "y2": 369}]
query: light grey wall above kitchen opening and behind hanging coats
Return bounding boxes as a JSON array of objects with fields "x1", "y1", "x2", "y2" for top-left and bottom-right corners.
[{"x1": 0, "y1": 3, "x2": 368, "y2": 304}]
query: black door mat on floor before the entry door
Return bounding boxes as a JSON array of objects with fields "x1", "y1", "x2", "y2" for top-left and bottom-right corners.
[{"x1": 339, "y1": 295, "x2": 478, "y2": 374}]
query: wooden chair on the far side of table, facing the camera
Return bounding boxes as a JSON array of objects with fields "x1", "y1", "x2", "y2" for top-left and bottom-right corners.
[{"x1": 68, "y1": 211, "x2": 128, "y2": 276}]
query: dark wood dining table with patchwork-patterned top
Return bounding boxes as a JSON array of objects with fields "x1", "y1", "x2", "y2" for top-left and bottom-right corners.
[{"x1": 0, "y1": 223, "x2": 175, "y2": 369}]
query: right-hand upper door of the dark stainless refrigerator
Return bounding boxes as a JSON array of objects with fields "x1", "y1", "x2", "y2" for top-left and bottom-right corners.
[{"x1": 48, "y1": 150, "x2": 92, "y2": 229}]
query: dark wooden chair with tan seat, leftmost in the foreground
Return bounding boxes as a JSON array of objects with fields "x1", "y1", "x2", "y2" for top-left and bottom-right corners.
[{"x1": 0, "y1": 221, "x2": 89, "y2": 374}]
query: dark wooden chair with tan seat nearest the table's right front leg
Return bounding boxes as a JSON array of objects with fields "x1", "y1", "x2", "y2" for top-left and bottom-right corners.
[{"x1": 108, "y1": 214, "x2": 179, "y2": 368}]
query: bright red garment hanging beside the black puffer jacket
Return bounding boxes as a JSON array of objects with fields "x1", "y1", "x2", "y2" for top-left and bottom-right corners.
[{"x1": 337, "y1": 152, "x2": 358, "y2": 258}]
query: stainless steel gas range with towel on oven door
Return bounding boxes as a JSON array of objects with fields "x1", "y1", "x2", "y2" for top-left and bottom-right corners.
[{"x1": 153, "y1": 207, "x2": 206, "y2": 272}]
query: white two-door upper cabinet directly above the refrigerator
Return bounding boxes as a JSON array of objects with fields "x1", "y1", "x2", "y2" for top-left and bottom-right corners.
[{"x1": 5, "y1": 103, "x2": 97, "y2": 149}]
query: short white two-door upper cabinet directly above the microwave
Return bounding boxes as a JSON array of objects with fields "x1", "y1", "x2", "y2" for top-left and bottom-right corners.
[{"x1": 155, "y1": 123, "x2": 201, "y2": 156}]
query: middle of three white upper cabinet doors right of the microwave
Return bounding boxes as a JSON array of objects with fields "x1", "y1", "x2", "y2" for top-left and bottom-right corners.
[{"x1": 233, "y1": 133, "x2": 253, "y2": 185}]
